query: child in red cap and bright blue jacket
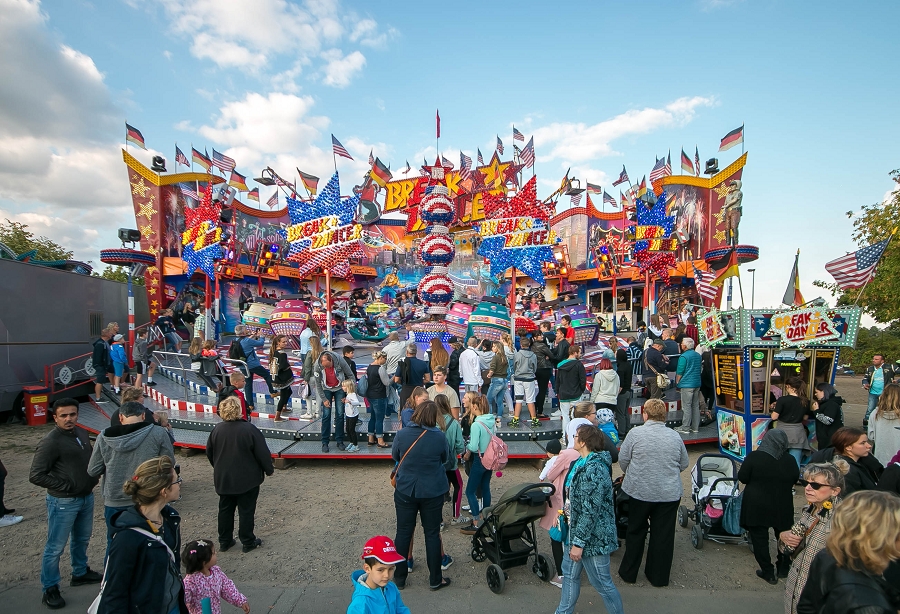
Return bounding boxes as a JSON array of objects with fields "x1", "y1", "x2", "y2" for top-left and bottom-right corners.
[{"x1": 347, "y1": 535, "x2": 409, "y2": 614}]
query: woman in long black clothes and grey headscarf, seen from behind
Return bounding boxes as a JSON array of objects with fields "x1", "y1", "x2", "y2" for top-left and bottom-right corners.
[{"x1": 738, "y1": 429, "x2": 800, "y2": 584}]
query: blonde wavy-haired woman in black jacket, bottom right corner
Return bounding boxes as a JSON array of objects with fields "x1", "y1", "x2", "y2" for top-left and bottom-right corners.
[{"x1": 797, "y1": 491, "x2": 900, "y2": 614}]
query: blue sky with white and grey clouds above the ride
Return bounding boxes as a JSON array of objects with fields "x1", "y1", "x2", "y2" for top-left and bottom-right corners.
[{"x1": 0, "y1": 0, "x2": 900, "y2": 318}]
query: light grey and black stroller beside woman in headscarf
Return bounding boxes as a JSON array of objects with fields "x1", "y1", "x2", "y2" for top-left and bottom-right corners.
[{"x1": 678, "y1": 454, "x2": 750, "y2": 550}]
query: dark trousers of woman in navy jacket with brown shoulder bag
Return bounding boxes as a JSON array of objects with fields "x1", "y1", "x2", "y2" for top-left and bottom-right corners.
[{"x1": 394, "y1": 490, "x2": 444, "y2": 588}]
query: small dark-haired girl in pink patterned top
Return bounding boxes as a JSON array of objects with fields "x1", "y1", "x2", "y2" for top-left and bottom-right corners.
[{"x1": 181, "y1": 539, "x2": 250, "y2": 614}]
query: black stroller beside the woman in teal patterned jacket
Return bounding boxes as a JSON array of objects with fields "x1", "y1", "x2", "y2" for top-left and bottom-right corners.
[{"x1": 472, "y1": 482, "x2": 556, "y2": 595}]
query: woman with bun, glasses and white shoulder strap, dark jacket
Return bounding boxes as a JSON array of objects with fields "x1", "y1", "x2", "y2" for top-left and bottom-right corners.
[{"x1": 97, "y1": 456, "x2": 188, "y2": 614}]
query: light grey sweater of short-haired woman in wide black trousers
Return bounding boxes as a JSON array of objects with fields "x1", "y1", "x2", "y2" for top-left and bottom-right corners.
[{"x1": 619, "y1": 420, "x2": 688, "y2": 503}]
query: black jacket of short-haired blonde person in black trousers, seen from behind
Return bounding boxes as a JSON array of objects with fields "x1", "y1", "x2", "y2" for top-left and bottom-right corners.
[{"x1": 206, "y1": 420, "x2": 275, "y2": 495}]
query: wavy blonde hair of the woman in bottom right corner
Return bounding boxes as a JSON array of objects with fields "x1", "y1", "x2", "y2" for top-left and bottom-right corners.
[{"x1": 826, "y1": 490, "x2": 900, "y2": 575}]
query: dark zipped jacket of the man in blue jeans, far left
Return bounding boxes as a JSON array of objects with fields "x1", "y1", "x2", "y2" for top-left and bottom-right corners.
[{"x1": 28, "y1": 426, "x2": 100, "y2": 497}]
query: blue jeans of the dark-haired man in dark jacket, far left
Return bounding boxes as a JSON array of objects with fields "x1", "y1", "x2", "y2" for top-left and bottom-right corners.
[{"x1": 41, "y1": 493, "x2": 94, "y2": 591}]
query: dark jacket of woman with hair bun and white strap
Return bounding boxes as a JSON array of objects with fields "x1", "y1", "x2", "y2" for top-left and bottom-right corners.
[{"x1": 97, "y1": 505, "x2": 188, "y2": 614}]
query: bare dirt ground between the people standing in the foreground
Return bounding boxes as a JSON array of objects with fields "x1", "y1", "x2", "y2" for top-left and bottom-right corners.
[{"x1": 0, "y1": 378, "x2": 865, "y2": 593}]
